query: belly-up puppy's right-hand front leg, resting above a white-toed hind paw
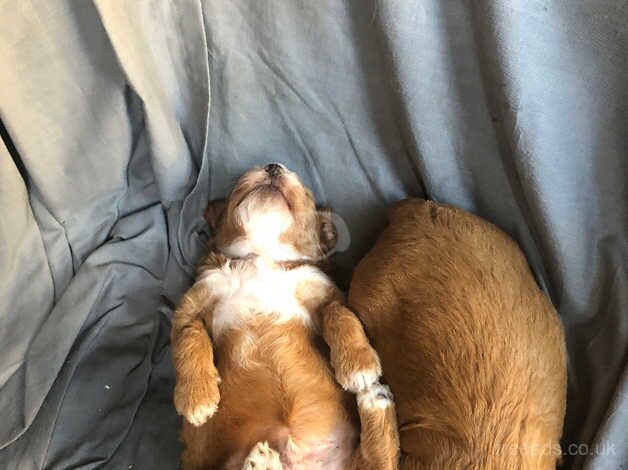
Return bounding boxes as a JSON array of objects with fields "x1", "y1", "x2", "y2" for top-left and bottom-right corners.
[{"x1": 322, "y1": 300, "x2": 382, "y2": 393}]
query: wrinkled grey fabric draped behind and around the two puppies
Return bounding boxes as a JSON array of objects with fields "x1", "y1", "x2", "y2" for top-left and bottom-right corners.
[{"x1": 0, "y1": 0, "x2": 628, "y2": 469}]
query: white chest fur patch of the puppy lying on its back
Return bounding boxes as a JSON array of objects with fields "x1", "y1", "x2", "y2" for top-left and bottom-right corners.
[{"x1": 203, "y1": 259, "x2": 330, "y2": 336}]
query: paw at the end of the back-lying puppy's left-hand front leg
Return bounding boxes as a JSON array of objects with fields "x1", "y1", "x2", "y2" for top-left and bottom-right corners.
[{"x1": 174, "y1": 376, "x2": 220, "y2": 426}]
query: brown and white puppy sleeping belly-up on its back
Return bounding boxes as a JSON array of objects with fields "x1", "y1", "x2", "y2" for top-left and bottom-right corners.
[{"x1": 171, "y1": 164, "x2": 398, "y2": 470}]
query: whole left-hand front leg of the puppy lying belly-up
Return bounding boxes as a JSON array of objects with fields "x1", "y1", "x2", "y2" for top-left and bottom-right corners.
[{"x1": 171, "y1": 282, "x2": 220, "y2": 426}]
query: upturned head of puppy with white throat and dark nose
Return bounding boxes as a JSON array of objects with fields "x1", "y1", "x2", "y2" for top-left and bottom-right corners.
[{"x1": 205, "y1": 163, "x2": 337, "y2": 261}]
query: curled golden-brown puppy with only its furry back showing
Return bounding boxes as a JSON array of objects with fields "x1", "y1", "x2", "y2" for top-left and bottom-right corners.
[{"x1": 348, "y1": 199, "x2": 566, "y2": 470}]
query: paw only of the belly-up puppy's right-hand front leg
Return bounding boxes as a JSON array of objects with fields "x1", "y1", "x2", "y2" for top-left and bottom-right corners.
[{"x1": 332, "y1": 344, "x2": 382, "y2": 393}]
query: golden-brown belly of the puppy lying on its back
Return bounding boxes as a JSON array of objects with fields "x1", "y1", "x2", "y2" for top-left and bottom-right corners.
[{"x1": 212, "y1": 318, "x2": 357, "y2": 470}]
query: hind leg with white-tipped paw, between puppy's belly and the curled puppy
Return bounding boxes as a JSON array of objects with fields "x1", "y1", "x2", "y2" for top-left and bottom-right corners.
[{"x1": 352, "y1": 383, "x2": 399, "y2": 470}]
